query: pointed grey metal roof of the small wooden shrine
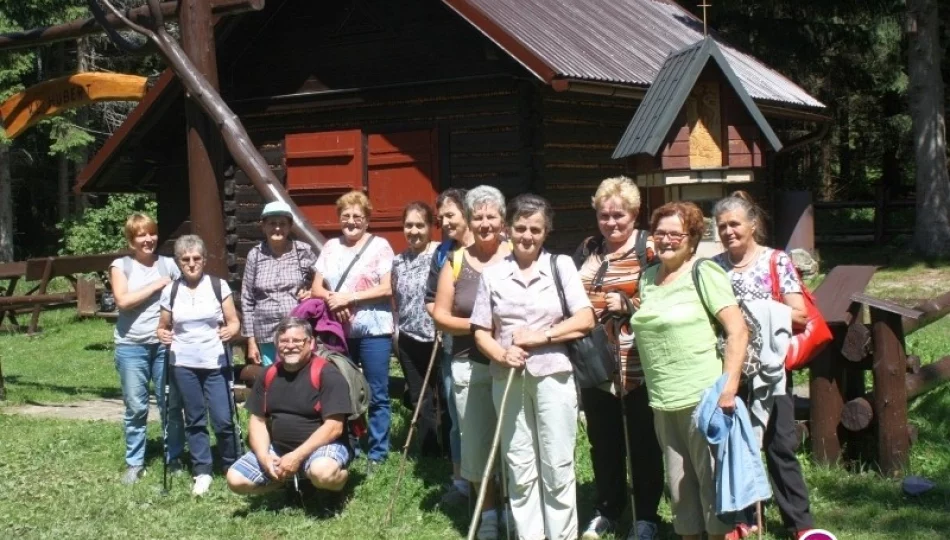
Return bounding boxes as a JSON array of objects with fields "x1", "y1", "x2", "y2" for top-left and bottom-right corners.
[{"x1": 613, "y1": 37, "x2": 782, "y2": 159}]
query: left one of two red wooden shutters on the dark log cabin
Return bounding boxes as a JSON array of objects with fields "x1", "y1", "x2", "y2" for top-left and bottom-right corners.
[{"x1": 284, "y1": 129, "x2": 363, "y2": 234}]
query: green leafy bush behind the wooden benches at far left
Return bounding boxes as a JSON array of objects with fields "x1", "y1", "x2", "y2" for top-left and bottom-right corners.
[{"x1": 56, "y1": 193, "x2": 158, "y2": 255}]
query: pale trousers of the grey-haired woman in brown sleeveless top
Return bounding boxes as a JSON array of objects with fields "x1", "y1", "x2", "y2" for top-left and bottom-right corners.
[{"x1": 452, "y1": 360, "x2": 498, "y2": 483}]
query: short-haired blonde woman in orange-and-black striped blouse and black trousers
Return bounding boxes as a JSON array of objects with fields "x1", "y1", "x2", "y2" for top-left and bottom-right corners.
[{"x1": 574, "y1": 176, "x2": 664, "y2": 540}]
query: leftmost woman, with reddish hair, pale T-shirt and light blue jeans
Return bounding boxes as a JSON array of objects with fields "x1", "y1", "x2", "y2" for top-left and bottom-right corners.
[{"x1": 109, "y1": 214, "x2": 185, "y2": 484}]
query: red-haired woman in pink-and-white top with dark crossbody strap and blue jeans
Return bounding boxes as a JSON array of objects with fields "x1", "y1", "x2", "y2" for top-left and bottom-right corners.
[{"x1": 311, "y1": 191, "x2": 394, "y2": 472}]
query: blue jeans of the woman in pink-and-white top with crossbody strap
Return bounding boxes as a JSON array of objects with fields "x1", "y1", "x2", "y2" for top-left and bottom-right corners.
[{"x1": 346, "y1": 335, "x2": 393, "y2": 461}]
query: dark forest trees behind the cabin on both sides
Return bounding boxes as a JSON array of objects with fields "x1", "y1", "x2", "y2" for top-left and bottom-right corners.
[{"x1": 0, "y1": 0, "x2": 950, "y2": 262}]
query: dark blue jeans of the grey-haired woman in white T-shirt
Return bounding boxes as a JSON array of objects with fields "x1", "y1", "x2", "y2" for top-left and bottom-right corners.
[{"x1": 172, "y1": 366, "x2": 238, "y2": 476}]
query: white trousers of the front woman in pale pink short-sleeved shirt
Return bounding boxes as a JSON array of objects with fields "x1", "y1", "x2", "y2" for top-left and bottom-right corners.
[{"x1": 492, "y1": 372, "x2": 577, "y2": 540}]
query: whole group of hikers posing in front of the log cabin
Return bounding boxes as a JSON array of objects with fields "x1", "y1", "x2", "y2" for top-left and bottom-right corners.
[{"x1": 111, "y1": 177, "x2": 813, "y2": 540}]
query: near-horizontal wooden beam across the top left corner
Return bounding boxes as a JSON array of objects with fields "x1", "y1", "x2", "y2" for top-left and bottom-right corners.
[{"x1": 0, "y1": 0, "x2": 264, "y2": 51}]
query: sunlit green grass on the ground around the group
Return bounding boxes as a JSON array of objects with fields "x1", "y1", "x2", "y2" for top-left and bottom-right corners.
[{"x1": 0, "y1": 286, "x2": 950, "y2": 540}]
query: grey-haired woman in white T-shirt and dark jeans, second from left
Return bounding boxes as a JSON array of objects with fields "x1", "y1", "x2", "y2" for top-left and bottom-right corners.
[{"x1": 158, "y1": 234, "x2": 241, "y2": 495}]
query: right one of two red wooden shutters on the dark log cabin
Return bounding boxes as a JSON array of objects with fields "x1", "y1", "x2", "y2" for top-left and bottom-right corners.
[{"x1": 366, "y1": 129, "x2": 439, "y2": 253}]
